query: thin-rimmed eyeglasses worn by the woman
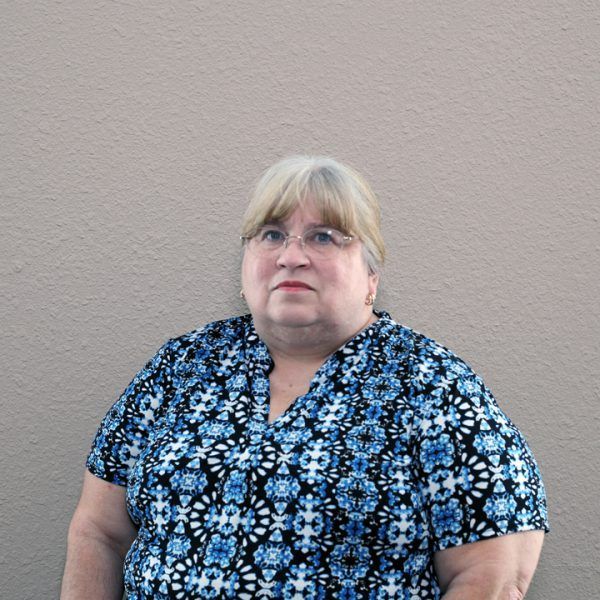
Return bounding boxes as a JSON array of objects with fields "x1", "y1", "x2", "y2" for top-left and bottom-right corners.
[{"x1": 240, "y1": 225, "x2": 354, "y2": 259}]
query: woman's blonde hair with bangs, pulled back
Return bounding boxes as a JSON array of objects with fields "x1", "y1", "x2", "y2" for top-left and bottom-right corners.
[{"x1": 242, "y1": 156, "x2": 385, "y2": 273}]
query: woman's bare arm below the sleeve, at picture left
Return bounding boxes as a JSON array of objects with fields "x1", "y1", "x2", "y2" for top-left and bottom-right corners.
[{"x1": 60, "y1": 472, "x2": 137, "y2": 600}]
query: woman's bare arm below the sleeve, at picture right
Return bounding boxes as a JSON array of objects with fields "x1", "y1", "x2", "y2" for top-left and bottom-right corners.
[{"x1": 434, "y1": 531, "x2": 544, "y2": 600}]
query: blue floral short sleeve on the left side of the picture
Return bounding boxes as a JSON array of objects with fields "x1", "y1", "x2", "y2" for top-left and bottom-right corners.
[{"x1": 86, "y1": 340, "x2": 173, "y2": 485}]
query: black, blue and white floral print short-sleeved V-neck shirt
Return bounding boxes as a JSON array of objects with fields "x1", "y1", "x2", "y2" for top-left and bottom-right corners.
[{"x1": 87, "y1": 312, "x2": 547, "y2": 600}]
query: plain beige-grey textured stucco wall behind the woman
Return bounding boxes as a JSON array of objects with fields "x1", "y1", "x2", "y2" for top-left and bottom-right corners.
[{"x1": 0, "y1": 0, "x2": 600, "y2": 600}]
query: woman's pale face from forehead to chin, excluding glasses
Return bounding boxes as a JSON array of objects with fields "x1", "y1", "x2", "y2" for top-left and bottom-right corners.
[{"x1": 242, "y1": 203, "x2": 378, "y2": 335}]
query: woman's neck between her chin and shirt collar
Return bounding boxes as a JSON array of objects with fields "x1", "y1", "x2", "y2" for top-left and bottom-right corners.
[{"x1": 254, "y1": 312, "x2": 378, "y2": 366}]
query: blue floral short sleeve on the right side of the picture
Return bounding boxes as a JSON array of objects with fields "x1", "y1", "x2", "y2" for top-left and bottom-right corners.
[{"x1": 413, "y1": 346, "x2": 548, "y2": 551}]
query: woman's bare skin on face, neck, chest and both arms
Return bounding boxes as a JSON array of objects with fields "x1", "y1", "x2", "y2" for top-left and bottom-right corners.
[{"x1": 61, "y1": 204, "x2": 543, "y2": 600}]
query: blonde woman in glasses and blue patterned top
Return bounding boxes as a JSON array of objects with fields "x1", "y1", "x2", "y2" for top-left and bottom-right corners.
[{"x1": 62, "y1": 157, "x2": 547, "y2": 600}]
